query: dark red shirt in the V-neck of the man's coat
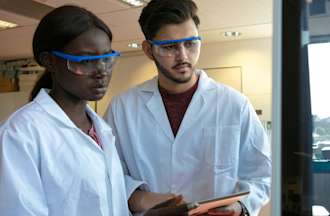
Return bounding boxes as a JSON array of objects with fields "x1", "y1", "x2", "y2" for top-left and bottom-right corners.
[{"x1": 159, "y1": 80, "x2": 198, "y2": 136}]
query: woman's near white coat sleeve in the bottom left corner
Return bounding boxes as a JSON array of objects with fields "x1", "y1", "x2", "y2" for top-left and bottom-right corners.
[{"x1": 0, "y1": 126, "x2": 48, "y2": 216}]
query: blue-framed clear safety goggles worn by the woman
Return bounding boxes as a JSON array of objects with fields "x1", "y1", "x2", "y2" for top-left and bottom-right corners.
[{"x1": 51, "y1": 50, "x2": 120, "y2": 75}]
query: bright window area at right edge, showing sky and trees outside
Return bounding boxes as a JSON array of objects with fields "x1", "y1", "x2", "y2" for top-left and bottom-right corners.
[{"x1": 308, "y1": 42, "x2": 330, "y2": 164}]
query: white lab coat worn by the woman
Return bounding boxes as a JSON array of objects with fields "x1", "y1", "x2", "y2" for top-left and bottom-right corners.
[{"x1": 0, "y1": 90, "x2": 138, "y2": 216}]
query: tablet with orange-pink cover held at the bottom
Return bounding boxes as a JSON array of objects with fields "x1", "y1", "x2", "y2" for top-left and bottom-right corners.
[{"x1": 189, "y1": 191, "x2": 250, "y2": 215}]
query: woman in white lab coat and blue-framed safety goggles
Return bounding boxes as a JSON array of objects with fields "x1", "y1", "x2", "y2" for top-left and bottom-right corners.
[{"x1": 0, "y1": 6, "x2": 196, "y2": 216}]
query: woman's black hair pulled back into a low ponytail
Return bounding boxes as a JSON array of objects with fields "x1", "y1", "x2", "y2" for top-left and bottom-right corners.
[{"x1": 30, "y1": 5, "x2": 112, "y2": 99}]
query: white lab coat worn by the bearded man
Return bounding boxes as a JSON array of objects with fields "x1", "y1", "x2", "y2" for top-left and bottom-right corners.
[{"x1": 105, "y1": 71, "x2": 271, "y2": 216}]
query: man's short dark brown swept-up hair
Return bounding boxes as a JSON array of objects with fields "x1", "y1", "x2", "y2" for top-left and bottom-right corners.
[{"x1": 139, "y1": 0, "x2": 199, "y2": 40}]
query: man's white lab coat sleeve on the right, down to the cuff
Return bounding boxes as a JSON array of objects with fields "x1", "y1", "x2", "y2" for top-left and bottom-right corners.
[{"x1": 238, "y1": 101, "x2": 271, "y2": 216}]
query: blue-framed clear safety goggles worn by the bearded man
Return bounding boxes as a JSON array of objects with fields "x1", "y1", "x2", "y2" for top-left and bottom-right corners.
[{"x1": 148, "y1": 36, "x2": 202, "y2": 57}]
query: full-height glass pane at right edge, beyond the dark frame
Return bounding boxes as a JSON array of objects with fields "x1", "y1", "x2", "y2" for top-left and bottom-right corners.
[{"x1": 308, "y1": 0, "x2": 330, "y2": 215}]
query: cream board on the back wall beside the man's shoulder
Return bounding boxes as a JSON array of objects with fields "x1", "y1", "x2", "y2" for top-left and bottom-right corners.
[{"x1": 203, "y1": 66, "x2": 243, "y2": 92}]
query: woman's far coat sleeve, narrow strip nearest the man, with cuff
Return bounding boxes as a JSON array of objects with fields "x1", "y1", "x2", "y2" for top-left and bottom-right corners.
[{"x1": 104, "y1": 100, "x2": 145, "y2": 198}]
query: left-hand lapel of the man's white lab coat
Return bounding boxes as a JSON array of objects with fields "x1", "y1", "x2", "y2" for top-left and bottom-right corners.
[{"x1": 142, "y1": 77, "x2": 174, "y2": 141}]
